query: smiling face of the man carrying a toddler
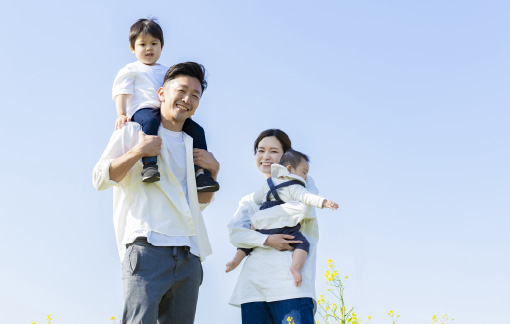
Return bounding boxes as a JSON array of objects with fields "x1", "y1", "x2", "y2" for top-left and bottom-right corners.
[{"x1": 158, "y1": 75, "x2": 202, "y2": 123}]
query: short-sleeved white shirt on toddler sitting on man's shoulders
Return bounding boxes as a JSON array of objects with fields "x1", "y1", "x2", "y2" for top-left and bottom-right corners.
[{"x1": 112, "y1": 61, "x2": 168, "y2": 118}]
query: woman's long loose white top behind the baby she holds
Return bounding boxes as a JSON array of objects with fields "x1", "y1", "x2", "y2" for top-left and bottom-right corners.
[{"x1": 228, "y1": 177, "x2": 319, "y2": 307}]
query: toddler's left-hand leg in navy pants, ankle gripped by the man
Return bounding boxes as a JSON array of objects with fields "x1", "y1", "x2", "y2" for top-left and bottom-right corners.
[{"x1": 131, "y1": 108, "x2": 161, "y2": 182}]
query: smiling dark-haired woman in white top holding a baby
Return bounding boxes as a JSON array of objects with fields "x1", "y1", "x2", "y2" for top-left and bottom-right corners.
[{"x1": 228, "y1": 129, "x2": 319, "y2": 324}]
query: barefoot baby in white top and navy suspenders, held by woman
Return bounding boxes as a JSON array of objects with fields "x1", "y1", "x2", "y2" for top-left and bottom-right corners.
[{"x1": 226, "y1": 150, "x2": 338, "y2": 286}]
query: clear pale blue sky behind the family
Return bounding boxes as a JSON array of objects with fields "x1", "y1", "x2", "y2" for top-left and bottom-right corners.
[{"x1": 0, "y1": 0, "x2": 510, "y2": 324}]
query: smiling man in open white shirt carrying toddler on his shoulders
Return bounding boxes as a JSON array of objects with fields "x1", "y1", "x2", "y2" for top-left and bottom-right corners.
[{"x1": 93, "y1": 62, "x2": 219, "y2": 324}]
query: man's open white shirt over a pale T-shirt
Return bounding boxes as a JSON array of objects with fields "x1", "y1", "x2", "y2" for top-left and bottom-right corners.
[{"x1": 93, "y1": 123, "x2": 212, "y2": 261}]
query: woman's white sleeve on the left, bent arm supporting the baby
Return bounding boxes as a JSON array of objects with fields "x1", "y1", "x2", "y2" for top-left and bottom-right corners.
[{"x1": 227, "y1": 194, "x2": 268, "y2": 249}]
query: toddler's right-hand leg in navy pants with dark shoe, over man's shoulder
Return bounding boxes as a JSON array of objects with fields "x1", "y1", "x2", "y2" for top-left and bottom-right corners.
[{"x1": 182, "y1": 118, "x2": 220, "y2": 192}]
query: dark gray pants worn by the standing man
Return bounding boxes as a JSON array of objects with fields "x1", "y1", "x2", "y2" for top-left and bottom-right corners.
[{"x1": 122, "y1": 238, "x2": 203, "y2": 324}]
